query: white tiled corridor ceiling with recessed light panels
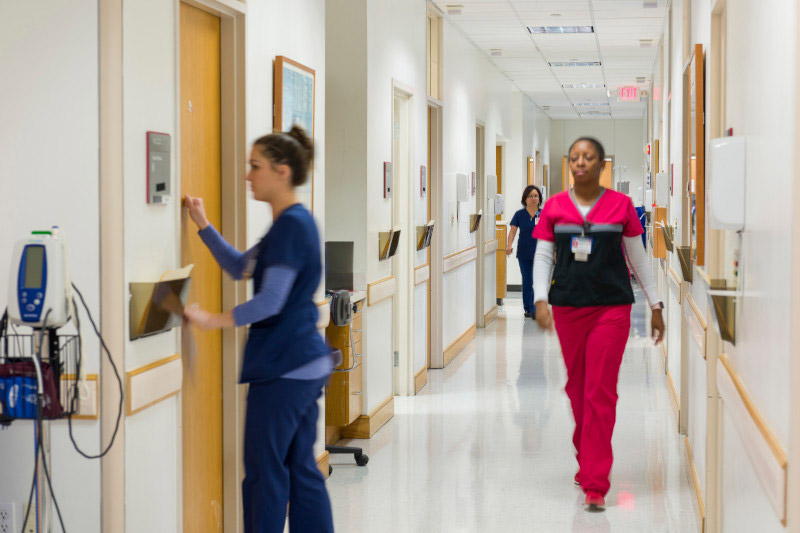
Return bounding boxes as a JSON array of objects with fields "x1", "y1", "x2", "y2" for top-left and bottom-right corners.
[{"x1": 434, "y1": 0, "x2": 669, "y2": 120}]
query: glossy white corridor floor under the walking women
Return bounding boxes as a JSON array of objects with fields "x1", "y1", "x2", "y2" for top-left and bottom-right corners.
[{"x1": 328, "y1": 293, "x2": 697, "y2": 533}]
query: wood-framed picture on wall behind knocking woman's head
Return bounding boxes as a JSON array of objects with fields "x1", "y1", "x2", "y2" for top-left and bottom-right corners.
[{"x1": 272, "y1": 56, "x2": 316, "y2": 211}]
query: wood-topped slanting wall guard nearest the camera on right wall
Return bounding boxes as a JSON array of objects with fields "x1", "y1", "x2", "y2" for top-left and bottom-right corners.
[{"x1": 717, "y1": 354, "x2": 788, "y2": 525}]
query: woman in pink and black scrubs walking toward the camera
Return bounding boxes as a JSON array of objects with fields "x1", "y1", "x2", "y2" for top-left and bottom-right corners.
[{"x1": 533, "y1": 137, "x2": 664, "y2": 511}]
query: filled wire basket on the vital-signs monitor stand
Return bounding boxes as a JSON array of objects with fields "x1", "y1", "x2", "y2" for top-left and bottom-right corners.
[{"x1": 0, "y1": 330, "x2": 81, "y2": 423}]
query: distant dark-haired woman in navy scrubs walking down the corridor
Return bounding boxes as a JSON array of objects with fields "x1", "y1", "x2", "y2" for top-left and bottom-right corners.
[{"x1": 506, "y1": 185, "x2": 542, "y2": 318}]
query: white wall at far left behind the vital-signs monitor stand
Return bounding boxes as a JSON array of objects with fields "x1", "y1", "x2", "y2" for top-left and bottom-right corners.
[{"x1": 0, "y1": 0, "x2": 100, "y2": 531}]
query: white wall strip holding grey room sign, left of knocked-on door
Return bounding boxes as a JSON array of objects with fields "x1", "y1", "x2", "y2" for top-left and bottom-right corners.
[{"x1": 123, "y1": 0, "x2": 182, "y2": 531}]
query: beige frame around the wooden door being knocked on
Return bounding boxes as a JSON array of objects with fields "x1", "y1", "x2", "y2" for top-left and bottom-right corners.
[{"x1": 174, "y1": 0, "x2": 248, "y2": 532}]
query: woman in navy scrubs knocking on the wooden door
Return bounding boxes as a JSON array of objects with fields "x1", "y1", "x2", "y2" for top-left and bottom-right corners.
[{"x1": 185, "y1": 126, "x2": 333, "y2": 533}]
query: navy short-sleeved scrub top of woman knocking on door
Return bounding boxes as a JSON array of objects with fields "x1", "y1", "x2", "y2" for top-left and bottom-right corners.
[{"x1": 240, "y1": 204, "x2": 329, "y2": 383}]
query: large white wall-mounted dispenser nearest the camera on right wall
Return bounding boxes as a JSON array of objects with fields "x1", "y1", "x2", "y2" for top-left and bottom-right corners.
[{"x1": 708, "y1": 137, "x2": 747, "y2": 231}]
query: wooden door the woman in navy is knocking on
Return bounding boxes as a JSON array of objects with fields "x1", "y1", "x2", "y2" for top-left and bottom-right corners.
[{"x1": 180, "y1": 4, "x2": 223, "y2": 533}]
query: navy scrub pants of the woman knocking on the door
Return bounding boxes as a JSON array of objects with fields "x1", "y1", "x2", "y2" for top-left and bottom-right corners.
[{"x1": 242, "y1": 377, "x2": 333, "y2": 533}]
